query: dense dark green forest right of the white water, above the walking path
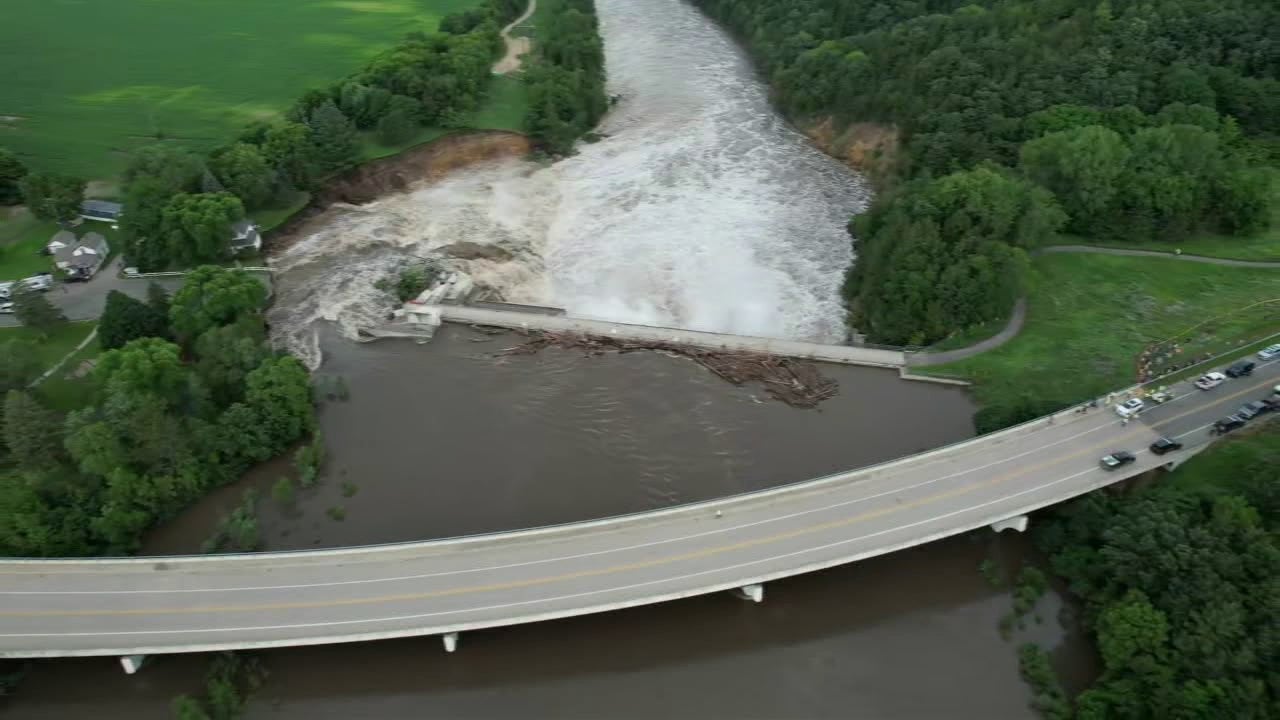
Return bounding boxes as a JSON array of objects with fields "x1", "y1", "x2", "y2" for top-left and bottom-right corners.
[{"x1": 695, "y1": 0, "x2": 1280, "y2": 345}]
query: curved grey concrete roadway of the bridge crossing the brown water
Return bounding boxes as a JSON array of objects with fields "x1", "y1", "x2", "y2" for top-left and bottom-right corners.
[{"x1": 0, "y1": 363, "x2": 1280, "y2": 657}]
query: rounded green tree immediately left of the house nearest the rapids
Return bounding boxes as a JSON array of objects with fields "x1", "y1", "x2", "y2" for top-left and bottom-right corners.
[{"x1": 160, "y1": 192, "x2": 244, "y2": 265}]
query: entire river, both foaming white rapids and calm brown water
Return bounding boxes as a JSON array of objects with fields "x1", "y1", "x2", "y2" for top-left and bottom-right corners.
[{"x1": 0, "y1": 0, "x2": 1091, "y2": 720}]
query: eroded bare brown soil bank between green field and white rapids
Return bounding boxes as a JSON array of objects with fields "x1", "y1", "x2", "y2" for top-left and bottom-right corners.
[{"x1": 268, "y1": 131, "x2": 532, "y2": 252}]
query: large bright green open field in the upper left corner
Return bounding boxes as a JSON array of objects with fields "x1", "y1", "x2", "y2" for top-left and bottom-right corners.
[{"x1": 0, "y1": 0, "x2": 479, "y2": 179}]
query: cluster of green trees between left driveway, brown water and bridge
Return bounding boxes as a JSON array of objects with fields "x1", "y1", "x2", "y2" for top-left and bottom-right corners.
[{"x1": 0, "y1": 266, "x2": 315, "y2": 557}]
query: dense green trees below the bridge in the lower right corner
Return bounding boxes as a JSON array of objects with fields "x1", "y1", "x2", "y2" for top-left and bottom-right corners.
[{"x1": 1036, "y1": 438, "x2": 1280, "y2": 720}]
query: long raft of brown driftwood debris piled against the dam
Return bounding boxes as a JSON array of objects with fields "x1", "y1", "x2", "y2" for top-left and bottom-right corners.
[{"x1": 495, "y1": 332, "x2": 840, "y2": 407}]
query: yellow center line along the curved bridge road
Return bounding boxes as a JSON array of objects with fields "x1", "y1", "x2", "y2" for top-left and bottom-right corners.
[{"x1": 0, "y1": 368, "x2": 1271, "y2": 618}]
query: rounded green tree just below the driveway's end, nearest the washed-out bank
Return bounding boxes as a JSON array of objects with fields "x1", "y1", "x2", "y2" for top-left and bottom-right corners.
[{"x1": 169, "y1": 265, "x2": 266, "y2": 342}]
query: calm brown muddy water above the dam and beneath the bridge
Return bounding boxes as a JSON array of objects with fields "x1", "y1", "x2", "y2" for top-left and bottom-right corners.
[{"x1": 0, "y1": 328, "x2": 1093, "y2": 720}]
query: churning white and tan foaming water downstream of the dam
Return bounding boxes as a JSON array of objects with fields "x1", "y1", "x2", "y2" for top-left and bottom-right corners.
[{"x1": 273, "y1": 0, "x2": 868, "y2": 363}]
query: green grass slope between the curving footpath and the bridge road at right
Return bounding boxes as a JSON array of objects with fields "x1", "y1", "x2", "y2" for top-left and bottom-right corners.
[{"x1": 918, "y1": 255, "x2": 1280, "y2": 405}]
